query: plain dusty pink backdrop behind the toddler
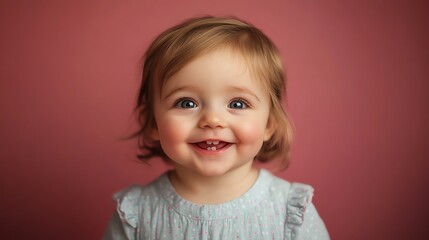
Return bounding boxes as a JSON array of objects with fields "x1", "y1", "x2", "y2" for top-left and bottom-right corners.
[{"x1": 0, "y1": 0, "x2": 429, "y2": 240}]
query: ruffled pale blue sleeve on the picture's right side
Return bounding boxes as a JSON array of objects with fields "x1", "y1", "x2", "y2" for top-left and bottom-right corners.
[{"x1": 285, "y1": 183, "x2": 329, "y2": 240}]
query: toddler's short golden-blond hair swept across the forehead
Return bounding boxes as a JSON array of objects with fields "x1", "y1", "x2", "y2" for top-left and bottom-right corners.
[{"x1": 133, "y1": 16, "x2": 292, "y2": 168}]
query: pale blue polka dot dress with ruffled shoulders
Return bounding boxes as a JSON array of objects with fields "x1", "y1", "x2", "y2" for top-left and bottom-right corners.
[{"x1": 105, "y1": 169, "x2": 329, "y2": 240}]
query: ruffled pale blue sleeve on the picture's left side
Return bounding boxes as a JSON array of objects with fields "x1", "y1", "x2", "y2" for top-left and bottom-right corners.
[{"x1": 104, "y1": 186, "x2": 142, "y2": 240}]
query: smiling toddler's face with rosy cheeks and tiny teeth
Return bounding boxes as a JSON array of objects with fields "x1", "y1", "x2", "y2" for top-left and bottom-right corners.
[{"x1": 153, "y1": 49, "x2": 272, "y2": 176}]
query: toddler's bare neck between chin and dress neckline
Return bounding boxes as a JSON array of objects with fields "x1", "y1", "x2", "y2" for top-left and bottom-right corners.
[{"x1": 170, "y1": 166, "x2": 259, "y2": 204}]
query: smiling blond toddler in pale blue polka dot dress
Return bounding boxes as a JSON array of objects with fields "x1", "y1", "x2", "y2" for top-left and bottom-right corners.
[{"x1": 105, "y1": 17, "x2": 329, "y2": 240}]
